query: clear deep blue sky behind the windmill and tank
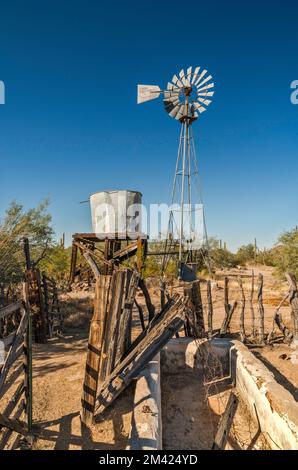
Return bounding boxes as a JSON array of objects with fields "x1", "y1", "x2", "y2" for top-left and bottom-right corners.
[{"x1": 0, "y1": 0, "x2": 298, "y2": 249}]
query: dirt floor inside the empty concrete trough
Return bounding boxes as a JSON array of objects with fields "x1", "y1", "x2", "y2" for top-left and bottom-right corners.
[{"x1": 161, "y1": 370, "x2": 269, "y2": 450}]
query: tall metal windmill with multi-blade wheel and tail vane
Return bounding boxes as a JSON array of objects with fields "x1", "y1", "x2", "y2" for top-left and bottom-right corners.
[{"x1": 137, "y1": 67, "x2": 214, "y2": 278}]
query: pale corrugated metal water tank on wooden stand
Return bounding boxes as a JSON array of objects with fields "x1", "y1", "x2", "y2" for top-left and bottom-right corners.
[{"x1": 90, "y1": 190, "x2": 142, "y2": 238}]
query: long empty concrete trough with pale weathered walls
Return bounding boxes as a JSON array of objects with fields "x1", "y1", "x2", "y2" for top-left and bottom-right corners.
[{"x1": 128, "y1": 338, "x2": 298, "y2": 450}]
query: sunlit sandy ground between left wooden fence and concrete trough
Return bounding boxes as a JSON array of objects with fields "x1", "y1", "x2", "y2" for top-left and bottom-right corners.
[{"x1": 33, "y1": 333, "x2": 133, "y2": 450}]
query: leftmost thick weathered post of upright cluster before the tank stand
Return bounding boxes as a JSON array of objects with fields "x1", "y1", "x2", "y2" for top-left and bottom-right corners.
[{"x1": 81, "y1": 276, "x2": 110, "y2": 426}]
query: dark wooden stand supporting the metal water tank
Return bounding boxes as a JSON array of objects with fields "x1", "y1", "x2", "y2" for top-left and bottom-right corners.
[{"x1": 70, "y1": 232, "x2": 148, "y2": 283}]
